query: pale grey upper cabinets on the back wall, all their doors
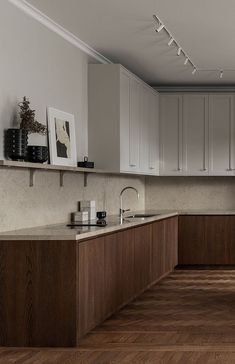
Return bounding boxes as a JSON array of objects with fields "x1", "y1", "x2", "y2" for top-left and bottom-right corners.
[{"x1": 160, "y1": 93, "x2": 235, "y2": 176}]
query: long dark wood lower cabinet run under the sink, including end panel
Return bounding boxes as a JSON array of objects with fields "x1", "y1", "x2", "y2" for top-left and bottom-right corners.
[{"x1": 0, "y1": 217, "x2": 177, "y2": 347}]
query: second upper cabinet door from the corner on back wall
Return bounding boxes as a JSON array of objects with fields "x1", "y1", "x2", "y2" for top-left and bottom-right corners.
[{"x1": 183, "y1": 94, "x2": 208, "y2": 176}]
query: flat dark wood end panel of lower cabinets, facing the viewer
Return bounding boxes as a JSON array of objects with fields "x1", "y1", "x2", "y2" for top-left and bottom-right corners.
[{"x1": 0, "y1": 241, "x2": 76, "y2": 346}]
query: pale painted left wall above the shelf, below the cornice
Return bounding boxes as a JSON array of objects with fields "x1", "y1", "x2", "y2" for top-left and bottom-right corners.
[{"x1": 0, "y1": 1, "x2": 88, "y2": 158}]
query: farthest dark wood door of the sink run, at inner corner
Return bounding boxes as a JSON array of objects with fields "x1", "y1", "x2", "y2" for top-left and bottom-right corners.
[{"x1": 164, "y1": 216, "x2": 178, "y2": 273}]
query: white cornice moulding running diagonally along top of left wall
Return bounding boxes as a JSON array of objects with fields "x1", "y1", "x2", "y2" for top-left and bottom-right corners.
[{"x1": 8, "y1": 0, "x2": 112, "y2": 64}]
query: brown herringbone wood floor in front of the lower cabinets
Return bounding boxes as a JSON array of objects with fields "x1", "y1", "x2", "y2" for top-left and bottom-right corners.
[{"x1": 0, "y1": 270, "x2": 235, "y2": 364}]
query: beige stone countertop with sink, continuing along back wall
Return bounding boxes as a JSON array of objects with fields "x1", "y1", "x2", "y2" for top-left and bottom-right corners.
[{"x1": 0, "y1": 210, "x2": 235, "y2": 241}]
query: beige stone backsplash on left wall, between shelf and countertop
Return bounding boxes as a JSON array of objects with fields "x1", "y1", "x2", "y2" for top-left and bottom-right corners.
[{"x1": 0, "y1": 168, "x2": 145, "y2": 231}]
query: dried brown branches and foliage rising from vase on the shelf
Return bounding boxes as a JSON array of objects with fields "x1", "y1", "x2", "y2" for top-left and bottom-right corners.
[{"x1": 19, "y1": 96, "x2": 47, "y2": 135}]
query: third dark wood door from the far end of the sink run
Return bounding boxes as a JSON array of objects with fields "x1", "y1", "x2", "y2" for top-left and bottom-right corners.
[{"x1": 134, "y1": 225, "x2": 152, "y2": 294}]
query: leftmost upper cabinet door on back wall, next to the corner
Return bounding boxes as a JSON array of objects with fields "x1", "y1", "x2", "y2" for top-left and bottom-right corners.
[{"x1": 160, "y1": 94, "x2": 183, "y2": 176}]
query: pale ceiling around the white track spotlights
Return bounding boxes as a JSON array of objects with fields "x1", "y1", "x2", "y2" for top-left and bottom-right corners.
[{"x1": 29, "y1": 0, "x2": 235, "y2": 85}]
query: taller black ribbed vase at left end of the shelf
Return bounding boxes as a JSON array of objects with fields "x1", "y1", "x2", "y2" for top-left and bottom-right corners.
[{"x1": 5, "y1": 128, "x2": 28, "y2": 161}]
